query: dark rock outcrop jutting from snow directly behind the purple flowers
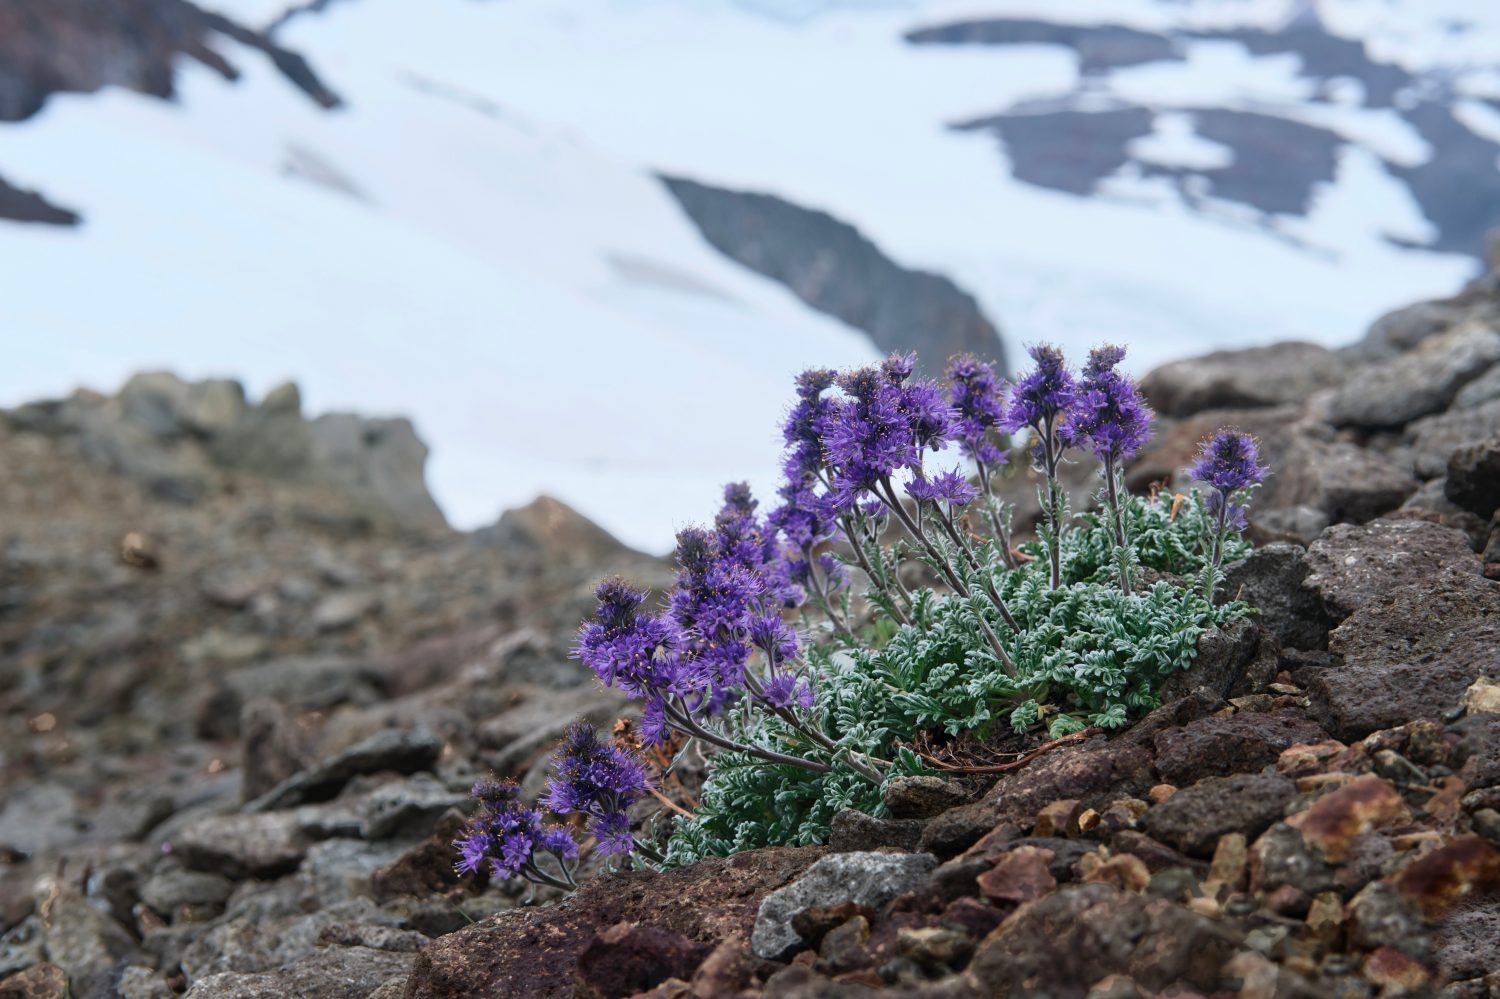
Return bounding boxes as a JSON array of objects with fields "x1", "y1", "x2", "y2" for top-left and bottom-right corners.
[{"x1": 662, "y1": 176, "x2": 1005, "y2": 374}]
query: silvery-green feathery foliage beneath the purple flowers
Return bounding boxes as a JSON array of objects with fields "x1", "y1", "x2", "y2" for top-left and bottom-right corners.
[{"x1": 668, "y1": 494, "x2": 1250, "y2": 863}]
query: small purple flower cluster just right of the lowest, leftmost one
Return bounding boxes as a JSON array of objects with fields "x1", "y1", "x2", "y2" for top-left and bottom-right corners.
[{"x1": 546, "y1": 722, "x2": 651, "y2": 854}]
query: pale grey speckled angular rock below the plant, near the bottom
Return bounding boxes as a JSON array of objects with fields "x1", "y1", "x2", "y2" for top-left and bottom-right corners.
[{"x1": 750, "y1": 854, "x2": 938, "y2": 960}]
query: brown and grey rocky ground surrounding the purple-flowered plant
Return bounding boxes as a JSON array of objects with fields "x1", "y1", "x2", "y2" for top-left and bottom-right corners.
[{"x1": 0, "y1": 244, "x2": 1500, "y2": 999}]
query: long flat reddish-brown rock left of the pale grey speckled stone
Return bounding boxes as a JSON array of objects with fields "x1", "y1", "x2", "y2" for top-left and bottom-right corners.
[{"x1": 407, "y1": 848, "x2": 822, "y2": 999}]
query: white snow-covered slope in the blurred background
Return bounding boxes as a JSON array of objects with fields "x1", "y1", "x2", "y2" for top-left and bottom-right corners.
[{"x1": 0, "y1": 0, "x2": 1490, "y2": 549}]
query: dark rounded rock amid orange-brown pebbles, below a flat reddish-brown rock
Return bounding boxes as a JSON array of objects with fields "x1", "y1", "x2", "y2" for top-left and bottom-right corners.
[{"x1": 1145, "y1": 774, "x2": 1296, "y2": 858}]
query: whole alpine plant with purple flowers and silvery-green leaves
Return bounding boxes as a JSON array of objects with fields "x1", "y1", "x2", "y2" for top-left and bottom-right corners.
[{"x1": 456, "y1": 344, "x2": 1266, "y2": 888}]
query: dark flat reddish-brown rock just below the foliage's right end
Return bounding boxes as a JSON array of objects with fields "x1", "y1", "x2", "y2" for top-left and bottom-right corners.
[{"x1": 1155, "y1": 711, "x2": 1328, "y2": 786}]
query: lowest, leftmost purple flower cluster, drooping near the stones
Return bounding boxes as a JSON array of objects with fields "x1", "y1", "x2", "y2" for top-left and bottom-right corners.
[{"x1": 453, "y1": 780, "x2": 578, "y2": 885}]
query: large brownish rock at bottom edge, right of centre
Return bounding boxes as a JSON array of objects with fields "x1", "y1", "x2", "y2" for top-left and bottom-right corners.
[{"x1": 969, "y1": 884, "x2": 1235, "y2": 996}]
